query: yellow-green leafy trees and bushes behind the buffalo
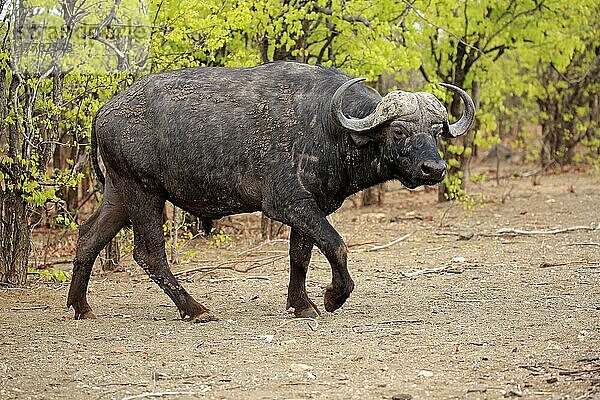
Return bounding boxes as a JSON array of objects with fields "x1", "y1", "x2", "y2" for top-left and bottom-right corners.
[{"x1": 0, "y1": 0, "x2": 600, "y2": 272}]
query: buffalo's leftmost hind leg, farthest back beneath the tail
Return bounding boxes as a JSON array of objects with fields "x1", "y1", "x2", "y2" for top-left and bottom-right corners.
[{"x1": 67, "y1": 181, "x2": 128, "y2": 319}]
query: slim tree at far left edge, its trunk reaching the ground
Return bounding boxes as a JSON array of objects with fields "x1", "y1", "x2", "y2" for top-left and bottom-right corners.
[{"x1": 0, "y1": 1, "x2": 79, "y2": 285}]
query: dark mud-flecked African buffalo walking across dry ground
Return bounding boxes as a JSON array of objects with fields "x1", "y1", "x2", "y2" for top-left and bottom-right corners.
[{"x1": 67, "y1": 62, "x2": 475, "y2": 321}]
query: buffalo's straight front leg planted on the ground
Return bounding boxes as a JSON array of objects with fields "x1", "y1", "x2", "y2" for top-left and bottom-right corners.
[{"x1": 287, "y1": 228, "x2": 321, "y2": 318}]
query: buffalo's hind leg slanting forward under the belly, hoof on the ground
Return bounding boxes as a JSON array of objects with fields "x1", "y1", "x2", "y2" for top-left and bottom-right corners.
[{"x1": 128, "y1": 191, "x2": 216, "y2": 322}]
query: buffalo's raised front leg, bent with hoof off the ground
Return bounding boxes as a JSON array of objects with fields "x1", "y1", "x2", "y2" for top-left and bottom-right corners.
[{"x1": 266, "y1": 200, "x2": 354, "y2": 311}]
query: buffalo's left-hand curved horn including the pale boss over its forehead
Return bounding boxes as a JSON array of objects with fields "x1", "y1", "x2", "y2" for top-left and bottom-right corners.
[{"x1": 331, "y1": 78, "x2": 418, "y2": 132}]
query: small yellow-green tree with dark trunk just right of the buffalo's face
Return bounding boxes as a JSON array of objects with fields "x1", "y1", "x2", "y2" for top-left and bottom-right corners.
[{"x1": 411, "y1": 0, "x2": 548, "y2": 201}]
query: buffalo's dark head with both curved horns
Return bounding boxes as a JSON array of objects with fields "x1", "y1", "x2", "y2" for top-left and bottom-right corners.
[{"x1": 332, "y1": 78, "x2": 475, "y2": 189}]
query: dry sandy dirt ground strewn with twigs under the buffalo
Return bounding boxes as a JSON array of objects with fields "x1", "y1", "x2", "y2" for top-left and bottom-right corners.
[{"x1": 0, "y1": 167, "x2": 600, "y2": 400}]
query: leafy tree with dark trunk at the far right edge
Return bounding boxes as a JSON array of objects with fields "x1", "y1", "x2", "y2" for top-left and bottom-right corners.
[{"x1": 530, "y1": 2, "x2": 600, "y2": 167}]
